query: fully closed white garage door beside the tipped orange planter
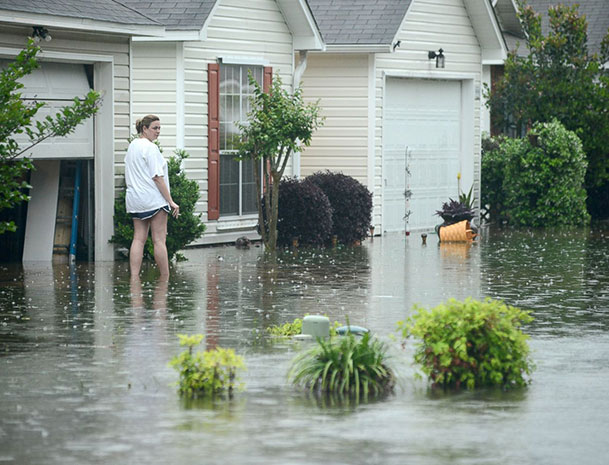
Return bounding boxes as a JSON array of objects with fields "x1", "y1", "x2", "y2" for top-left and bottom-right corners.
[{"x1": 383, "y1": 78, "x2": 461, "y2": 232}]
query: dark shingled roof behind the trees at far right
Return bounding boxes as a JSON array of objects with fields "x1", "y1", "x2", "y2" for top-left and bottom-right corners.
[{"x1": 527, "y1": 0, "x2": 609, "y2": 53}]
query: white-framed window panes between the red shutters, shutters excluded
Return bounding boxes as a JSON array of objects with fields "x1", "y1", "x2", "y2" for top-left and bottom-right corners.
[{"x1": 219, "y1": 64, "x2": 263, "y2": 217}]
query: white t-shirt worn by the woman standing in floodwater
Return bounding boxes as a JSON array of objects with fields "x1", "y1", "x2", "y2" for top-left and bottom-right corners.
[{"x1": 125, "y1": 137, "x2": 169, "y2": 213}]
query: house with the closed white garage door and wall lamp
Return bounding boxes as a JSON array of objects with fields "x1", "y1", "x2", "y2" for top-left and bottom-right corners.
[{"x1": 300, "y1": 0, "x2": 507, "y2": 232}]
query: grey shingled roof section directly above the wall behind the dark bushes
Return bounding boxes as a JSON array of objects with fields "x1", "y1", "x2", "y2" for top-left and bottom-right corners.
[{"x1": 307, "y1": 0, "x2": 411, "y2": 45}]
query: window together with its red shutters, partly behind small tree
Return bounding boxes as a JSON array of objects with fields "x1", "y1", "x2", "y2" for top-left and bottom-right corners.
[{"x1": 207, "y1": 63, "x2": 273, "y2": 220}]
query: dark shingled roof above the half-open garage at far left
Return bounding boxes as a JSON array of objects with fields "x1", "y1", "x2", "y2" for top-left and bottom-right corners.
[{"x1": 0, "y1": 0, "x2": 160, "y2": 26}]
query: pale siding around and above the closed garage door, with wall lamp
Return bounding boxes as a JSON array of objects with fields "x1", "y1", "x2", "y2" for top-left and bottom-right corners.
[{"x1": 373, "y1": 0, "x2": 482, "y2": 226}]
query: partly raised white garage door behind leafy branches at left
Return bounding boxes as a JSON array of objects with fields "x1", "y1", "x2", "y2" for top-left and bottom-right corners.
[{"x1": 0, "y1": 60, "x2": 94, "y2": 159}]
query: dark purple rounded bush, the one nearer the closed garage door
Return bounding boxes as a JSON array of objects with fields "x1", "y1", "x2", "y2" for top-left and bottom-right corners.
[{"x1": 307, "y1": 171, "x2": 372, "y2": 245}]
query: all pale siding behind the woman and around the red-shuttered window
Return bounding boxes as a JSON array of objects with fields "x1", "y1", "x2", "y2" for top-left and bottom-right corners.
[{"x1": 133, "y1": 0, "x2": 293, "y2": 243}]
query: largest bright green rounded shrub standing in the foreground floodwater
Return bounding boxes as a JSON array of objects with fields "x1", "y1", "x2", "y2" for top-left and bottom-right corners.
[{"x1": 398, "y1": 299, "x2": 534, "y2": 389}]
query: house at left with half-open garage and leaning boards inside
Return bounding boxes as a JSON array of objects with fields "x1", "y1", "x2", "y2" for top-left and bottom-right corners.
[{"x1": 0, "y1": 0, "x2": 164, "y2": 261}]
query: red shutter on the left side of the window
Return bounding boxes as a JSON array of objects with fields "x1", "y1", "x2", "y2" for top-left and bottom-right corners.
[{"x1": 207, "y1": 63, "x2": 220, "y2": 220}]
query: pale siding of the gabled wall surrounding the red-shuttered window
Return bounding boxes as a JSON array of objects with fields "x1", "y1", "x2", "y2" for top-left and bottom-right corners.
[{"x1": 184, "y1": 0, "x2": 293, "y2": 234}]
